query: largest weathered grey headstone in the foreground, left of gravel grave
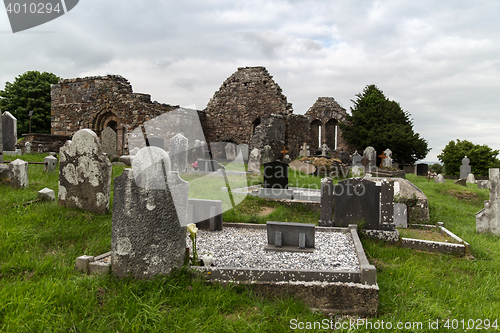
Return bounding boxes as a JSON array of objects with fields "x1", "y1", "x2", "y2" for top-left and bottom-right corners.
[{"x1": 111, "y1": 161, "x2": 186, "y2": 278}]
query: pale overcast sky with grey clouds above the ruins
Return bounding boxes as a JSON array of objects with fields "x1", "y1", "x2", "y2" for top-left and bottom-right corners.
[{"x1": 0, "y1": 0, "x2": 500, "y2": 161}]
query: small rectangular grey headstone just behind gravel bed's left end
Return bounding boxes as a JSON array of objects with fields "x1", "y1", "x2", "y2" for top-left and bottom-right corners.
[{"x1": 187, "y1": 199, "x2": 223, "y2": 231}]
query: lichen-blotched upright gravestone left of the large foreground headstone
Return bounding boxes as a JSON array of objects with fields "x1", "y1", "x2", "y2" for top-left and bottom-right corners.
[{"x1": 58, "y1": 129, "x2": 112, "y2": 214}]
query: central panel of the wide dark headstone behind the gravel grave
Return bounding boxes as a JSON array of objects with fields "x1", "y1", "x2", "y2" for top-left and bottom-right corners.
[{"x1": 333, "y1": 178, "x2": 380, "y2": 229}]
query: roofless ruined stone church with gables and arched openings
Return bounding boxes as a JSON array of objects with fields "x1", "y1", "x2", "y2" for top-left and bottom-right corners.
[{"x1": 51, "y1": 67, "x2": 347, "y2": 158}]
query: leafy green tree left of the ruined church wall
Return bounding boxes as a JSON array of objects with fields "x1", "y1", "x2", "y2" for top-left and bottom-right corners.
[{"x1": 0, "y1": 71, "x2": 60, "y2": 137}]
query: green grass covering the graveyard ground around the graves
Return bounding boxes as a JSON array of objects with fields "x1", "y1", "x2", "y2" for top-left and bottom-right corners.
[{"x1": 0, "y1": 154, "x2": 500, "y2": 332}]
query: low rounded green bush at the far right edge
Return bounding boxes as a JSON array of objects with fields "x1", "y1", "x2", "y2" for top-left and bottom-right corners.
[{"x1": 438, "y1": 139, "x2": 500, "y2": 176}]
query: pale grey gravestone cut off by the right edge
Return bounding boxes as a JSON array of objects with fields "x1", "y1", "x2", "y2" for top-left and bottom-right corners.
[{"x1": 476, "y1": 169, "x2": 500, "y2": 236}]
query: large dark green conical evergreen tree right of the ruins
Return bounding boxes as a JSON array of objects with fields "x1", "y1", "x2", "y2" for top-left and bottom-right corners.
[{"x1": 340, "y1": 84, "x2": 430, "y2": 164}]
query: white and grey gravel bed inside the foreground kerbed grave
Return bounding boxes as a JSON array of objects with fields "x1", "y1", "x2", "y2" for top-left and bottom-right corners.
[{"x1": 186, "y1": 227, "x2": 359, "y2": 272}]
